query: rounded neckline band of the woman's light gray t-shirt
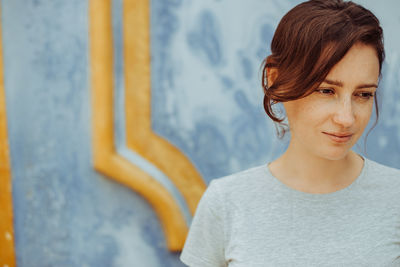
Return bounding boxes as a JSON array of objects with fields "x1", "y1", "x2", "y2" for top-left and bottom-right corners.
[{"x1": 264, "y1": 155, "x2": 369, "y2": 201}]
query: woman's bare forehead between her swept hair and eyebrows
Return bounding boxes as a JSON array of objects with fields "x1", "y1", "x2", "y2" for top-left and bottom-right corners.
[{"x1": 326, "y1": 43, "x2": 379, "y2": 85}]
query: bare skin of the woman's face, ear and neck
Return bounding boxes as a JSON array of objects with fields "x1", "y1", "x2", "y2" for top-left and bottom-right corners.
[{"x1": 268, "y1": 43, "x2": 379, "y2": 193}]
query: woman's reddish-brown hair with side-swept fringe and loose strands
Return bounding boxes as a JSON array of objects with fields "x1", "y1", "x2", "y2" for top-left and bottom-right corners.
[{"x1": 262, "y1": 0, "x2": 385, "y2": 137}]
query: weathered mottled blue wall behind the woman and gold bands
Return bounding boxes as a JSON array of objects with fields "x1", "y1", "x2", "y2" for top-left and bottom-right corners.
[{"x1": 1, "y1": 0, "x2": 400, "y2": 267}]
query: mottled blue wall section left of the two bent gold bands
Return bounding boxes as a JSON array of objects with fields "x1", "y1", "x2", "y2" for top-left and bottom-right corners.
[{"x1": 1, "y1": 0, "x2": 182, "y2": 267}]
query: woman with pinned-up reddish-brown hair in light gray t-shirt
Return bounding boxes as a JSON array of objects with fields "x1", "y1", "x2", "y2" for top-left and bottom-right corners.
[{"x1": 181, "y1": 0, "x2": 400, "y2": 267}]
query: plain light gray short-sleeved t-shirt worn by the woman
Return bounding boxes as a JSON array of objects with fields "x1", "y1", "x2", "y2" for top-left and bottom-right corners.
[{"x1": 180, "y1": 159, "x2": 400, "y2": 267}]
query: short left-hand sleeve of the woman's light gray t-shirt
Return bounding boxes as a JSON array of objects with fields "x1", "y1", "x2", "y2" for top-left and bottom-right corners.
[{"x1": 180, "y1": 181, "x2": 227, "y2": 267}]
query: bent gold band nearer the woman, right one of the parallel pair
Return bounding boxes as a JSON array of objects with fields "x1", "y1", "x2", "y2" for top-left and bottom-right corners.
[{"x1": 123, "y1": 0, "x2": 206, "y2": 219}]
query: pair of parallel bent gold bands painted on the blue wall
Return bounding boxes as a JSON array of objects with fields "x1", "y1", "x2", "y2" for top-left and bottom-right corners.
[{"x1": 89, "y1": 0, "x2": 206, "y2": 251}]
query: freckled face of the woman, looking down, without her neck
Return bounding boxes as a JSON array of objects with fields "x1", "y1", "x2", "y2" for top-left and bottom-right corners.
[{"x1": 284, "y1": 43, "x2": 379, "y2": 160}]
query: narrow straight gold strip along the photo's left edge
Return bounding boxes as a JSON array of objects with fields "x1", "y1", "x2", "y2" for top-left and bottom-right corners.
[{"x1": 0, "y1": 3, "x2": 16, "y2": 267}]
